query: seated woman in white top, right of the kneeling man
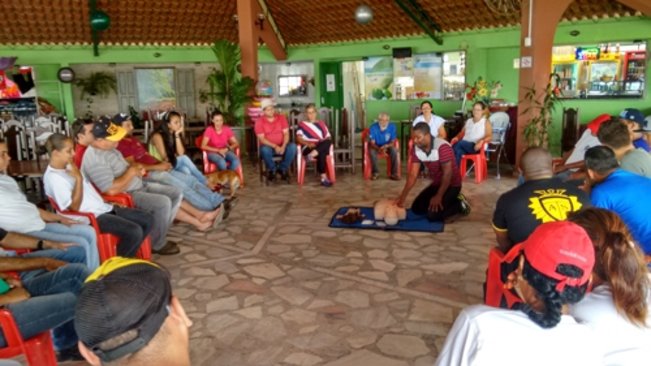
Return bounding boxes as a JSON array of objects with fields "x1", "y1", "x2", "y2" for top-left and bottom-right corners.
[{"x1": 452, "y1": 102, "x2": 493, "y2": 164}]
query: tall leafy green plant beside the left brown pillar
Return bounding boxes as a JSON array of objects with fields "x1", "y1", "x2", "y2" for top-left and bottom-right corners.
[{"x1": 199, "y1": 40, "x2": 255, "y2": 125}]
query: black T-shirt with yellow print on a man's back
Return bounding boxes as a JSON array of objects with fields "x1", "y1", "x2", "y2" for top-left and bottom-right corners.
[{"x1": 493, "y1": 178, "x2": 590, "y2": 244}]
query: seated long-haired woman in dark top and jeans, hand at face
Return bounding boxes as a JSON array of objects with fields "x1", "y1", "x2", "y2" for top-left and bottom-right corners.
[{"x1": 148, "y1": 111, "x2": 208, "y2": 185}]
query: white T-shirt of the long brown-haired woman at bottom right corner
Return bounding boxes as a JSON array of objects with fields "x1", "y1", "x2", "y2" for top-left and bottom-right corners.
[{"x1": 570, "y1": 284, "x2": 651, "y2": 366}]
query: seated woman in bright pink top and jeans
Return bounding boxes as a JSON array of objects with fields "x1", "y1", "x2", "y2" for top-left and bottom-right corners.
[{"x1": 201, "y1": 110, "x2": 240, "y2": 170}]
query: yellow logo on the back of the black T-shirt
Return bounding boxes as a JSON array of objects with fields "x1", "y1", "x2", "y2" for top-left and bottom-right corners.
[{"x1": 528, "y1": 189, "x2": 583, "y2": 224}]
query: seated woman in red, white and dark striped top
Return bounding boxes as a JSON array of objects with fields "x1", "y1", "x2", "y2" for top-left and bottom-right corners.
[{"x1": 296, "y1": 103, "x2": 332, "y2": 187}]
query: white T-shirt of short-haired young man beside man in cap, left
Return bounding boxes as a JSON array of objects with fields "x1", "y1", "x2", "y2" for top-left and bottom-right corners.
[{"x1": 43, "y1": 165, "x2": 113, "y2": 217}]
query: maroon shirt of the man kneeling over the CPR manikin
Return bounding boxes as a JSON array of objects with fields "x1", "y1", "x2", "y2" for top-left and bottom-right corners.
[{"x1": 411, "y1": 136, "x2": 461, "y2": 187}]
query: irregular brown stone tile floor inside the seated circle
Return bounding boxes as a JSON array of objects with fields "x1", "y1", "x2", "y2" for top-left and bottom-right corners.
[{"x1": 62, "y1": 167, "x2": 516, "y2": 366}]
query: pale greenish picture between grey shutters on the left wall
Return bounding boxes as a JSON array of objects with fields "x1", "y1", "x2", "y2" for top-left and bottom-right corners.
[{"x1": 136, "y1": 67, "x2": 176, "y2": 111}]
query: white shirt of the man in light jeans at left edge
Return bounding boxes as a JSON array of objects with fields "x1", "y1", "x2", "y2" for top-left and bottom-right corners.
[{"x1": 0, "y1": 174, "x2": 45, "y2": 234}]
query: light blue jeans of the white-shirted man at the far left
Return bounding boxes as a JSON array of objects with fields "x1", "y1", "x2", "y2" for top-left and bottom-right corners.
[{"x1": 26, "y1": 223, "x2": 99, "y2": 270}]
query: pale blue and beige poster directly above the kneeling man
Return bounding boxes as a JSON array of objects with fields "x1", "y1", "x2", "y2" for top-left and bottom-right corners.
[{"x1": 413, "y1": 53, "x2": 443, "y2": 99}]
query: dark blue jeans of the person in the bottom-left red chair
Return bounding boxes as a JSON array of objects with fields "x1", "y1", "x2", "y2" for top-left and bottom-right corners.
[{"x1": 0, "y1": 247, "x2": 91, "y2": 350}]
